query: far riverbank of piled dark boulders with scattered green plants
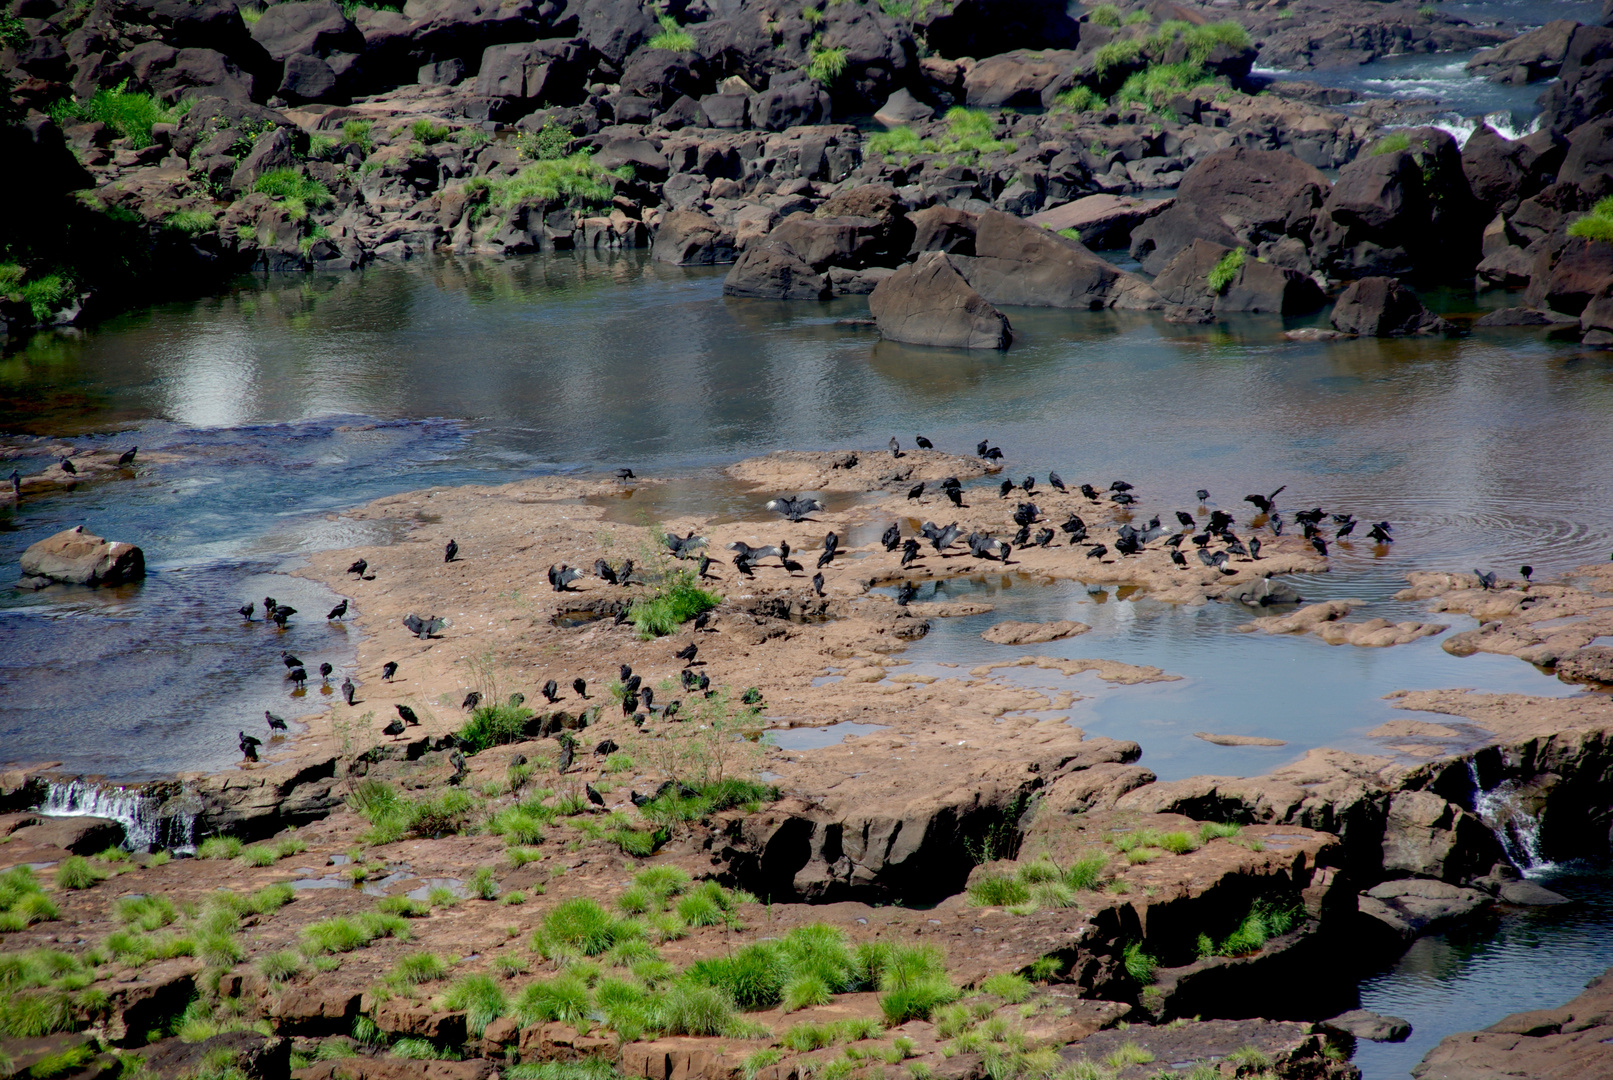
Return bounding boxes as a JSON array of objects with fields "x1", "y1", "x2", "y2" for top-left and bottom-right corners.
[{"x1": 0, "y1": 0, "x2": 1613, "y2": 347}]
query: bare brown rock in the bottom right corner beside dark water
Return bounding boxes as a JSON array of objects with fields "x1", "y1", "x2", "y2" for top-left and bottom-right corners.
[{"x1": 1411, "y1": 970, "x2": 1613, "y2": 1080}]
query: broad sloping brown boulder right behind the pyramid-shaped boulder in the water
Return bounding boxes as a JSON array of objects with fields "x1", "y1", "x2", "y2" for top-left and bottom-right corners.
[{"x1": 953, "y1": 210, "x2": 1165, "y2": 309}]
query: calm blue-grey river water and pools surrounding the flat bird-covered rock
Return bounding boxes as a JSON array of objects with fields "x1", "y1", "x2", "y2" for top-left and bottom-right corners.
[{"x1": 0, "y1": 245, "x2": 1613, "y2": 1078}]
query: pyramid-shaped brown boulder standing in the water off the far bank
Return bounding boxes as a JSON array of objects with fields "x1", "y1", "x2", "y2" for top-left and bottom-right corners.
[{"x1": 868, "y1": 251, "x2": 1013, "y2": 348}]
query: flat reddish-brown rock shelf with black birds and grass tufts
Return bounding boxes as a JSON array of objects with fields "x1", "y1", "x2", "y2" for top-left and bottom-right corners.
[{"x1": 0, "y1": 450, "x2": 1613, "y2": 1080}]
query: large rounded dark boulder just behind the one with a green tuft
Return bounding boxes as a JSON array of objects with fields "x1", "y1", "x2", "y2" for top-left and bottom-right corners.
[{"x1": 1131, "y1": 147, "x2": 1327, "y2": 274}]
